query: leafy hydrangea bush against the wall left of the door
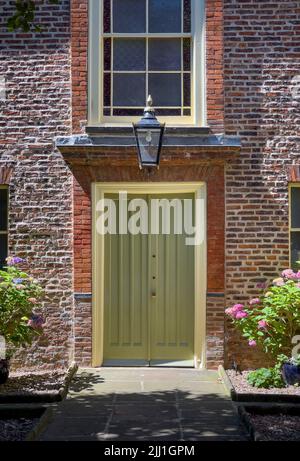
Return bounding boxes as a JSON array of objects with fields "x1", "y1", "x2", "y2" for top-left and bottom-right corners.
[{"x1": 0, "y1": 257, "x2": 44, "y2": 356}]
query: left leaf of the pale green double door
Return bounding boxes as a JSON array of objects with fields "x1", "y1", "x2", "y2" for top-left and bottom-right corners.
[{"x1": 104, "y1": 196, "x2": 149, "y2": 363}]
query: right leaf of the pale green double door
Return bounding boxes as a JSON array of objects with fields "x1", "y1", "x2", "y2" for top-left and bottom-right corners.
[{"x1": 150, "y1": 194, "x2": 194, "y2": 363}]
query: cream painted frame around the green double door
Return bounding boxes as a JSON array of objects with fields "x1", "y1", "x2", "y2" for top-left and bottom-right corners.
[{"x1": 92, "y1": 182, "x2": 207, "y2": 368}]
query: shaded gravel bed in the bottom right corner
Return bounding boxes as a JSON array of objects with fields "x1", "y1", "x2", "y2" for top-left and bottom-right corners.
[{"x1": 248, "y1": 413, "x2": 300, "y2": 442}]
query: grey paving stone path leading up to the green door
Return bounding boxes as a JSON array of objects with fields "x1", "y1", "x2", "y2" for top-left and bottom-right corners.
[{"x1": 40, "y1": 368, "x2": 247, "y2": 442}]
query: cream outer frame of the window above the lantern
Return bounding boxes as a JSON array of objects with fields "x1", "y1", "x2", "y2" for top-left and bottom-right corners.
[{"x1": 88, "y1": 0, "x2": 207, "y2": 127}]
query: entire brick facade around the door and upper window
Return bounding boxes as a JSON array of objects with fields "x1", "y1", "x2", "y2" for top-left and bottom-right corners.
[{"x1": 0, "y1": 0, "x2": 300, "y2": 368}]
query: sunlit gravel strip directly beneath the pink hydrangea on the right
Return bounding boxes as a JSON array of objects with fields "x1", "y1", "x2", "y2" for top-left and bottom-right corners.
[{"x1": 226, "y1": 370, "x2": 300, "y2": 395}]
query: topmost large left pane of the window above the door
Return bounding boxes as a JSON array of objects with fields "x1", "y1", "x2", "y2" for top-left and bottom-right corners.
[{"x1": 113, "y1": 0, "x2": 146, "y2": 33}]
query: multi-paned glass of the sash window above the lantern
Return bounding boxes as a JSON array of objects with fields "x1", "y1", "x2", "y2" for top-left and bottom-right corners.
[{"x1": 102, "y1": 0, "x2": 192, "y2": 117}]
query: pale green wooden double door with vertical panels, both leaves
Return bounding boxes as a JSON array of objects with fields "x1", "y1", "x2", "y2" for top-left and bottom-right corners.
[{"x1": 104, "y1": 194, "x2": 195, "y2": 366}]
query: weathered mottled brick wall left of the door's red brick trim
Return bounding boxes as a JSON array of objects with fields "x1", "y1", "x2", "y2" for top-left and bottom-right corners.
[{"x1": 0, "y1": 0, "x2": 73, "y2": 367}]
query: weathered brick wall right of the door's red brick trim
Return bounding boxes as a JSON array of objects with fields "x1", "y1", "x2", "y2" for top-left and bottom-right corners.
[{"x1": 224, "y1": 0, "x2": 300, "y2": 367}]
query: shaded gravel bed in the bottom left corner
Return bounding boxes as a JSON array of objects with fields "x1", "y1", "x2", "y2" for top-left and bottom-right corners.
[{"x1": 0, "y1": 418, "x2": 38, "y2": 442}]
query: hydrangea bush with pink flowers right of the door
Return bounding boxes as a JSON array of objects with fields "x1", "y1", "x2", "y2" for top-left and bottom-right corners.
[{"x1": 226, "y1": 269, "x2": 300, "y2": 359}]
